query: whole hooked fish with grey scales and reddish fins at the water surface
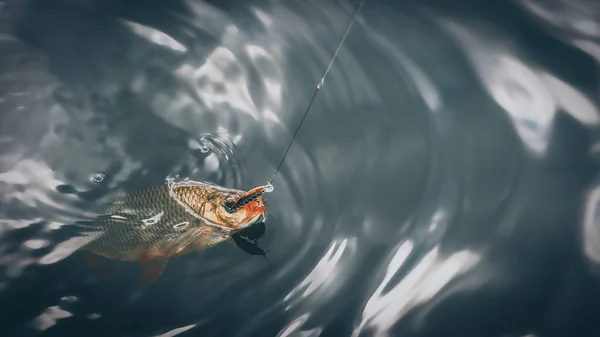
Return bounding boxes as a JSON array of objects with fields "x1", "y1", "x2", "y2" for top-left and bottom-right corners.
[{"x1": 77, "y1": 180, "x2": 266, "y2": 284}]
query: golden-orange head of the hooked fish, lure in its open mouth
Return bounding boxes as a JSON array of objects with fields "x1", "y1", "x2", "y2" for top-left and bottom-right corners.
[{"x1": 216, "y1": 186, "x2": 267, "y2": 230}]
